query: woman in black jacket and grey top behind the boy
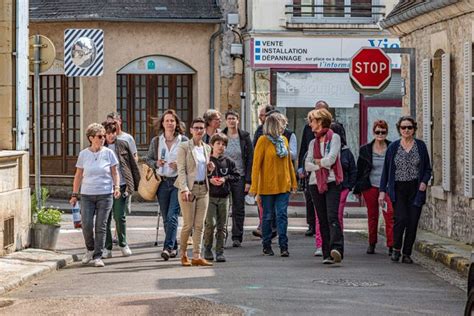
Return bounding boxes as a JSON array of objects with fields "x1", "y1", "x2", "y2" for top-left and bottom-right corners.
[{"x1": 222, "y1": 110, "x2": 253, "y2": 247}]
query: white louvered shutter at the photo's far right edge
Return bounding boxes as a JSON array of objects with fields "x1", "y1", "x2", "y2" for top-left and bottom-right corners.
[{"x1": 463, "y1": 42, "x2": 474, "y2": 198}]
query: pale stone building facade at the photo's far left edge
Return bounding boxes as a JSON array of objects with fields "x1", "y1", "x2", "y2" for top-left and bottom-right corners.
[{"x1": 0, "y1": 0, "x2": 31, "y2": 256}]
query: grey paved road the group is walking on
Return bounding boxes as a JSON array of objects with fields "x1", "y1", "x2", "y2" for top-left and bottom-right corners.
[{"x1": 0, "y1": 218, "x2": 465, "y2": 315}]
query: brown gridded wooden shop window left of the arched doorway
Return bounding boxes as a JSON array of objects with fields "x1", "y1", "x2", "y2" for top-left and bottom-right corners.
[{"x1": 29, "y1": 75, "x2": 81, "y2": 175}]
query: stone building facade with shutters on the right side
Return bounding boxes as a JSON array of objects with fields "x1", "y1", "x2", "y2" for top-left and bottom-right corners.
[{"x1": 381, "y1": 0, "x2": 474, "y2": 242}]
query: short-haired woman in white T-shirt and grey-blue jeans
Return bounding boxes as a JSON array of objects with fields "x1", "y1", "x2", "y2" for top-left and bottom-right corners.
[{"x1": 69, "y1": 123, "x2": 121, "y2": 267}]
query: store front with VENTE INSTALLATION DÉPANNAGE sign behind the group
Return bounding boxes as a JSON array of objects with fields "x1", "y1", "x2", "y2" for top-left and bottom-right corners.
[{"x1": 249, "y1": 37, "x2": 402, "y2": 201}]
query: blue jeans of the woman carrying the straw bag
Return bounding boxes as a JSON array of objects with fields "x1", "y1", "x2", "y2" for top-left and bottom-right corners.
[{"x1": 156, "y1": 179, "x2": 180, "y2": 250}]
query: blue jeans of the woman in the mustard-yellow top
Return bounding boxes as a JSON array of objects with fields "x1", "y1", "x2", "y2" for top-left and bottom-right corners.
[{"x1": 260, "y1": 192, "x2": 290, "y2": 250}]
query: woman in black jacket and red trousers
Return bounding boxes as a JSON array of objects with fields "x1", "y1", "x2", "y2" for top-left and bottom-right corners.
[{"x1": 354, "y1": 120, "x2": 393, "y2": 255}]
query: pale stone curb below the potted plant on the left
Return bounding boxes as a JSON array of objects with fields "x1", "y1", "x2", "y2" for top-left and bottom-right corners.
[{"x1": 0, "y1": 251, "x2": 77, "y2": 295}]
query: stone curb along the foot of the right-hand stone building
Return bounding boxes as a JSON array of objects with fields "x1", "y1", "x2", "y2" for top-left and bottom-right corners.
[{"x1": 414, "y1": 240, "x2": 471, "y2": 277}]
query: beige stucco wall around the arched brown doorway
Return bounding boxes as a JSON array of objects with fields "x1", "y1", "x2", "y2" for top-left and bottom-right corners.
[{"x1": 30, "y1": 22, "x2": 219, "y2": 144}]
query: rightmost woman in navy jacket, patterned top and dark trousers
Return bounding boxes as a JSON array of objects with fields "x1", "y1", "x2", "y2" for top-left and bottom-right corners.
[{"x1": 379, "y1": 116, "x2": 432, "y2": 263}]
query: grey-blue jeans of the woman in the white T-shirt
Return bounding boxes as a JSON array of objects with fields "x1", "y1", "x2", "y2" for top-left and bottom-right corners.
[{"x1": 81, "y1": 194, "x2": 113, "y2": 259}]
